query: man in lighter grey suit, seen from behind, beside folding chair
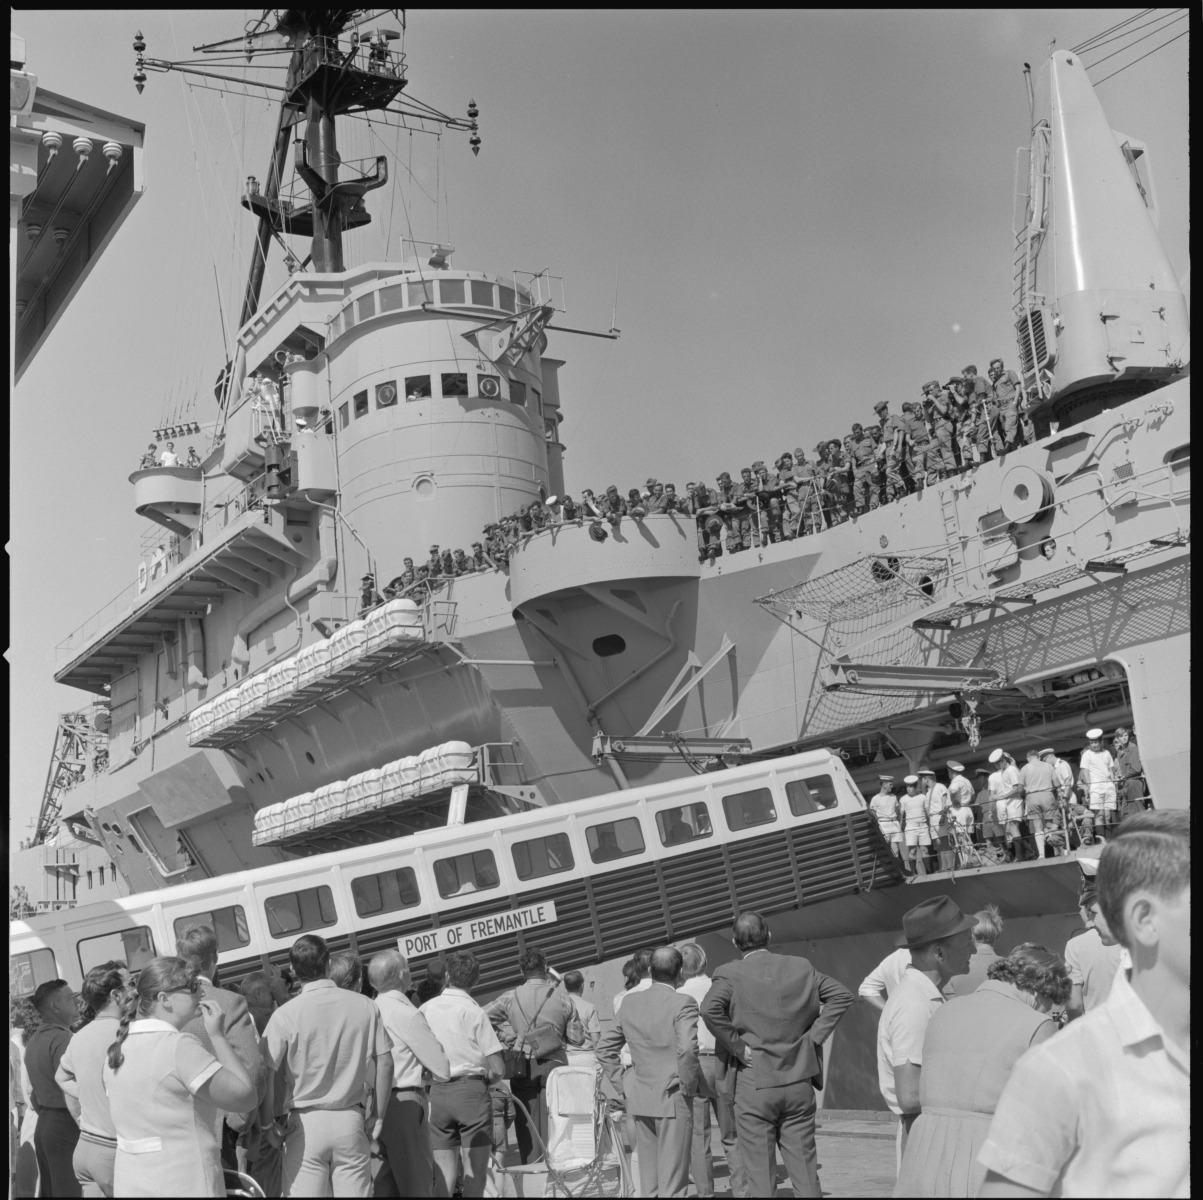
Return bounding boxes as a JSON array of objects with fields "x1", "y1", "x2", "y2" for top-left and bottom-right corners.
[{"x1": 598, "y1": 946, "x2": 704, "y2": 1196}]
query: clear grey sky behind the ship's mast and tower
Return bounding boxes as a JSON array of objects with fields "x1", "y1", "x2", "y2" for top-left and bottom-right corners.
[{"x1": 8, "y1": 8, "x2": 1190, "y2": 839}]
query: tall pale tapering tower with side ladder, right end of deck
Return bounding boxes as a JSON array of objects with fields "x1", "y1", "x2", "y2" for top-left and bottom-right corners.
[{"x1": 1014, "y1": 51, "x2": 1190, "y2": 426}]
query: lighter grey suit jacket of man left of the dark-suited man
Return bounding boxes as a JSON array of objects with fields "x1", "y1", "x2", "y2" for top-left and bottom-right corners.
[{"x1": 598, "y1": 984, "x2": 701, "y2": 1117}]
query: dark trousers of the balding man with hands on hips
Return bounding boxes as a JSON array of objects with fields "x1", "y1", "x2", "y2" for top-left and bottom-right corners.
[{"x1": 735, "y1": 1070, "x2": 823, "y2": 1196}]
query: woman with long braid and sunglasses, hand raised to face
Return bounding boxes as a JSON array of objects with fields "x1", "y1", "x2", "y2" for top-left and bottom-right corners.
[{"x1": 103, "y1": 958, "x2": 256, "y2": 1196}]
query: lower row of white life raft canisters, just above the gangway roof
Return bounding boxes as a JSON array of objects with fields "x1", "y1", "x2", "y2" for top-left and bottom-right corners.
[{"x1": 253, "y1": 742, "x2": 480, "y2": 845}]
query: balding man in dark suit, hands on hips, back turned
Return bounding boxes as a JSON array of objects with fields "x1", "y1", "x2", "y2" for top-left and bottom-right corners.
[{"x1": 701, "y1": 911, "x2": 853, "y2": 1196}]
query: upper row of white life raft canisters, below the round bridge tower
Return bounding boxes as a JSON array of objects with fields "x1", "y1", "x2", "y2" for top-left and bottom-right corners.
[{"x1": 188, "y1": 600, "x2": 423, "y2": 745}]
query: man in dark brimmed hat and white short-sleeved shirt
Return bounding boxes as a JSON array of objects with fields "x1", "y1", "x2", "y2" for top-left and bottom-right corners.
[{"x1": 877, "y1": 896, "x2": 974, "y2": 1164}]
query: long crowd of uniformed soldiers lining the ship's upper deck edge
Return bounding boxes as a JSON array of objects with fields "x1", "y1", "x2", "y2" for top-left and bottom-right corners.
[{"x1": 361, "y1": 358, "x2": 1036, "y2": 611}]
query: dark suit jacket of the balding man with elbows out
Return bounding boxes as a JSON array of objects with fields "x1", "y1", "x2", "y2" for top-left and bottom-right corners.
[{"x1": 697, "y1": 950, "x2": 854, "y2": 1088}]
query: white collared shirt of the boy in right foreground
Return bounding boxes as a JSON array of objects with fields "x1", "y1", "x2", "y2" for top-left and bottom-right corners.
[{"x1": 978, "y1": 973, "x2": 1191, "y2": 1198}]
